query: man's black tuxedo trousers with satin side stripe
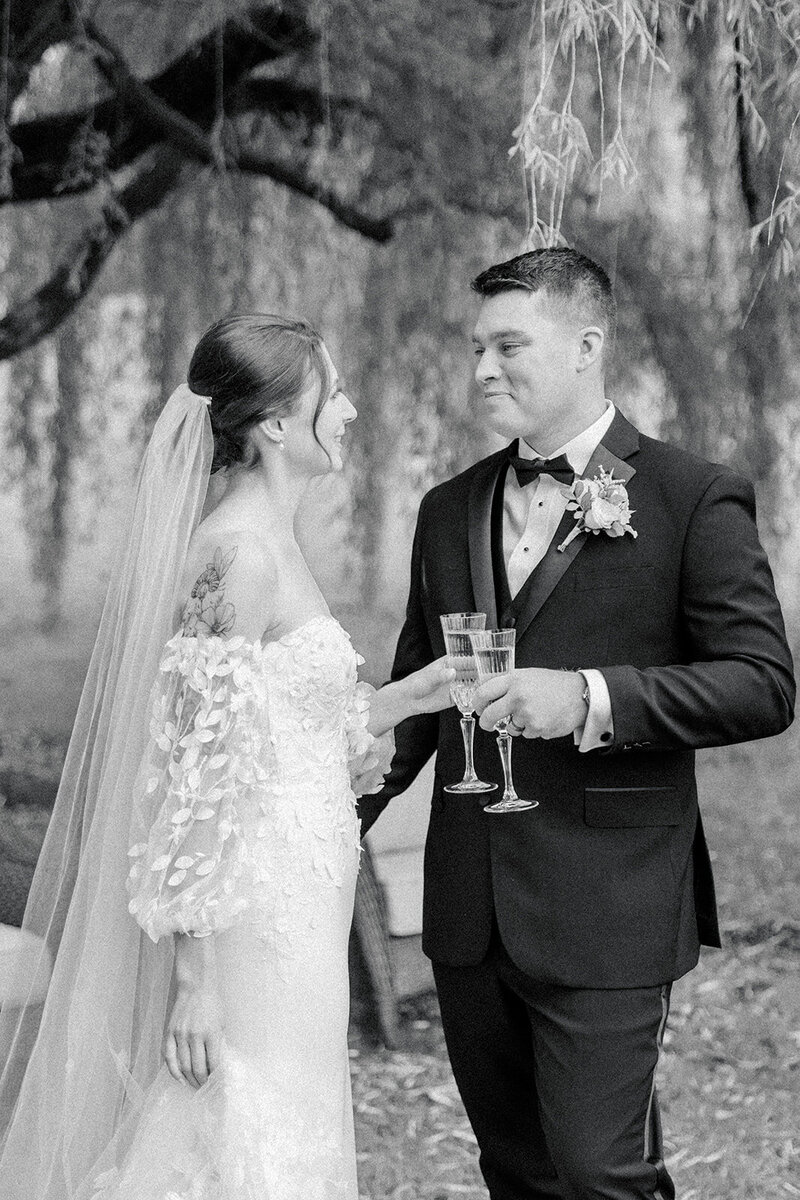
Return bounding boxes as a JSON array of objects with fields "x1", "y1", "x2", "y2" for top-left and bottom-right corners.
[{"x1": 433, "y1": 926, "x2": 675, "y2": 1200}]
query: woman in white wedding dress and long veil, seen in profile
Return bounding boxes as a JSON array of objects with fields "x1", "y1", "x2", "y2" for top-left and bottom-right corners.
[{"x1": 0, "y1": 316, "x2": 451, "y2": 1200}]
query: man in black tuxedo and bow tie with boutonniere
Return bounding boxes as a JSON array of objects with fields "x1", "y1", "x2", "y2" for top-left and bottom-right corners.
[{"x1": 360, "y1": 248, "x2": 794, "y2": 1200}]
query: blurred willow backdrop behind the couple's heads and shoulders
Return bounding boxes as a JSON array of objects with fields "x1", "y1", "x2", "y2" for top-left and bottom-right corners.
[{"x1": 0, "y1": 0, "x2": 800, "y2": 745}]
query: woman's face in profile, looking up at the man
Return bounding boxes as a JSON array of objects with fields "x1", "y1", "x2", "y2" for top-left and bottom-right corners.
[{"x1": 285, "y1": 346, "x2": 357, "y2": 475}]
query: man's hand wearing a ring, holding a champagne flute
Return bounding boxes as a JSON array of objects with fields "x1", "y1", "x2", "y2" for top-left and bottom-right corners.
[{"x1": 475, "y1": 667, "x2": 588, "y2": 738}]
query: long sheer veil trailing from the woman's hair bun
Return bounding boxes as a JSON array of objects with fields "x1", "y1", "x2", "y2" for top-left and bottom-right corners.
[{"x1": 0, "y1": 385, "x2": 212, "y2": 1200}]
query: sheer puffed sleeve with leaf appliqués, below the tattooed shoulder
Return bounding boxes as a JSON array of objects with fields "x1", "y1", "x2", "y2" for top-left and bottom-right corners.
[{"x1": 128, "y1": 634, "x2": 279, "y2": 941}]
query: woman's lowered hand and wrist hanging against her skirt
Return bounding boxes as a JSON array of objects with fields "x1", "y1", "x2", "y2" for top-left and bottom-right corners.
[{"x1": 164, "y1": 934, "x2": 222, "y2": 1087}]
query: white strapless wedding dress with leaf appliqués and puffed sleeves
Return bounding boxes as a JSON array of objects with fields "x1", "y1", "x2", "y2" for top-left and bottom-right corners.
[{"x1": 94, "y1": 616, "x2": 392, "y2": 1200}]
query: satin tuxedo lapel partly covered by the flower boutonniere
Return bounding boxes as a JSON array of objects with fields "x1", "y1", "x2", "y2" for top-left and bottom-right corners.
[{"x1": 513, "y1": 412, "x2": 639, "y2": 640}]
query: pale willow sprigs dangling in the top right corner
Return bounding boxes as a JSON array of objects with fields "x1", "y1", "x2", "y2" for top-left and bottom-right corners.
[{"x1": 520, "y1": 0, "x2": 800, "y2": 277}]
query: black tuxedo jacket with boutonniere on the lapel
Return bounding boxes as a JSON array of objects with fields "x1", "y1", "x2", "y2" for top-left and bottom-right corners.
[{"x1": 360, "y1": 413, "x2": 794, "y2": 988}]
